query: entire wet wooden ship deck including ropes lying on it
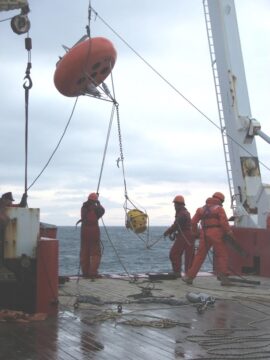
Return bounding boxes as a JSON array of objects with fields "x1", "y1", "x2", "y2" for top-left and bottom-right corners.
[{"x1": 0, "y1": 274, "x2": 270, "y2": 360}]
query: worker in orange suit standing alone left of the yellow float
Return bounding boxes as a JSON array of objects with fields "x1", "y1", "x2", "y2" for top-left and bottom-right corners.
[{"x1": 80, "y1": 193, "x2": 105, "y2": 279}]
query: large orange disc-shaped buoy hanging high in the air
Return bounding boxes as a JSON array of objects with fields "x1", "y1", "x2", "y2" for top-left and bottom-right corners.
[{"x1": 54, "y1": 37, "x2": 117, "y2": 97}]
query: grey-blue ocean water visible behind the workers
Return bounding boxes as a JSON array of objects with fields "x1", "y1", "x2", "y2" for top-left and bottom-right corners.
[{"x1": 57, "y1": 226, "x2": 212, "y2": 276}]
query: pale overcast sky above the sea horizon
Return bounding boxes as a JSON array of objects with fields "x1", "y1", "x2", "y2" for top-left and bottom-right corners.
[{"x1": 0, "y1": 0, "x2": 270, "y2": 225}]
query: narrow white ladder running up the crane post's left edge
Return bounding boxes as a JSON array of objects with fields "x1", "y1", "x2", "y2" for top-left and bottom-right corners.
[{"x1": 203, "y1": 0, "x2": 236, "y2": 213}]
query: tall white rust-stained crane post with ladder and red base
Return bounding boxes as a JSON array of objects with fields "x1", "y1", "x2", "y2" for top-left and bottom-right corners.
[{"x1": 203, "y1": 0, "x2": 270, "y2": 276}]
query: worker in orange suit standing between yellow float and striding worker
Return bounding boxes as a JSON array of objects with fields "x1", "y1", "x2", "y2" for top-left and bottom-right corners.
[{"x1": 163, "y1": 195, "x2": 194, "y2": 277}]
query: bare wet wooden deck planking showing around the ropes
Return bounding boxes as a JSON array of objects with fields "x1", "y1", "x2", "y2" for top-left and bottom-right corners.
[{"x1": 0, "y1": 278, "x2": 270, "y2": 360}]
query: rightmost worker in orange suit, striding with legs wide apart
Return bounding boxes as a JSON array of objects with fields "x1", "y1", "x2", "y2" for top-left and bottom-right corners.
[{"x1": 182, "y1": 192, "x2": 233, "y2": 285}]
